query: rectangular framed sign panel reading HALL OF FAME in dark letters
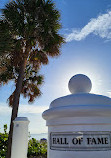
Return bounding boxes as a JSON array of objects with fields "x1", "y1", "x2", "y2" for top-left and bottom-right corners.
[{"x1": 50, "y1": 131, "x2": 111, "y2": 151}]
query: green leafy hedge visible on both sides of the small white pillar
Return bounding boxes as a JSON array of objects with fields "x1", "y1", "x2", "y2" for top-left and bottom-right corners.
[{"x1": 0, "y1": 125, "x2": 47, "y2": 158}]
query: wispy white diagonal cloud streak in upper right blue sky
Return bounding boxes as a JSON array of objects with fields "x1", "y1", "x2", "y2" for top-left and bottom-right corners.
[{"x1": 66, "y1": 11, "x2": 111, "y2": 42}]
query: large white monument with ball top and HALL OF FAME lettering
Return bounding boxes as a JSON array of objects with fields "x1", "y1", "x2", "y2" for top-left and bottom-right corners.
[{"x1": 43, "y1": 74, "x2": 111, "y2": 158}]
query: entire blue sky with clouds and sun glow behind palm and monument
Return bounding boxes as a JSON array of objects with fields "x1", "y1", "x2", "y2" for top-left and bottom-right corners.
[{"x1": 0, "y1": 0, "x2": 111, "y2": 134}]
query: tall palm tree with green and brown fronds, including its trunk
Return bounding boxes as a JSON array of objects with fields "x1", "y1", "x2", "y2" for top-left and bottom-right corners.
[{"x1": 0, "y1": 0, "x2": 64, "y2": 158}]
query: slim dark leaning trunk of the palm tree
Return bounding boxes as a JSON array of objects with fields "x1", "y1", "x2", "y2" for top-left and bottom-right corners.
[{"x1": 6, "y1": 59, "x2": 26, "y2": 158}]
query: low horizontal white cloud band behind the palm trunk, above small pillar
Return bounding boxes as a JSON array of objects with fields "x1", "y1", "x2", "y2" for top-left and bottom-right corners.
[{"x1": 0, "y1": 104, "x2": 48, "y2": 114}]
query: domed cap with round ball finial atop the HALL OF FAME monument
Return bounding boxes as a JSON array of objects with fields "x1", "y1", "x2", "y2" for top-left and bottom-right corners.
[{"x1": 42, "y1": 74, "x2": 111, "y2": 123}]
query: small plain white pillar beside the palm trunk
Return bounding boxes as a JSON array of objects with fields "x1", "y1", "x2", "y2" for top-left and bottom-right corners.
[{"x1": 11, "y1": 117, "x2": 29, "y2": 158}]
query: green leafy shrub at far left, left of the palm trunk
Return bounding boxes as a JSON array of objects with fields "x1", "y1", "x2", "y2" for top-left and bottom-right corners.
[{"x1": 0, "y1": 125, "x2": 8, "y2": 158}]
